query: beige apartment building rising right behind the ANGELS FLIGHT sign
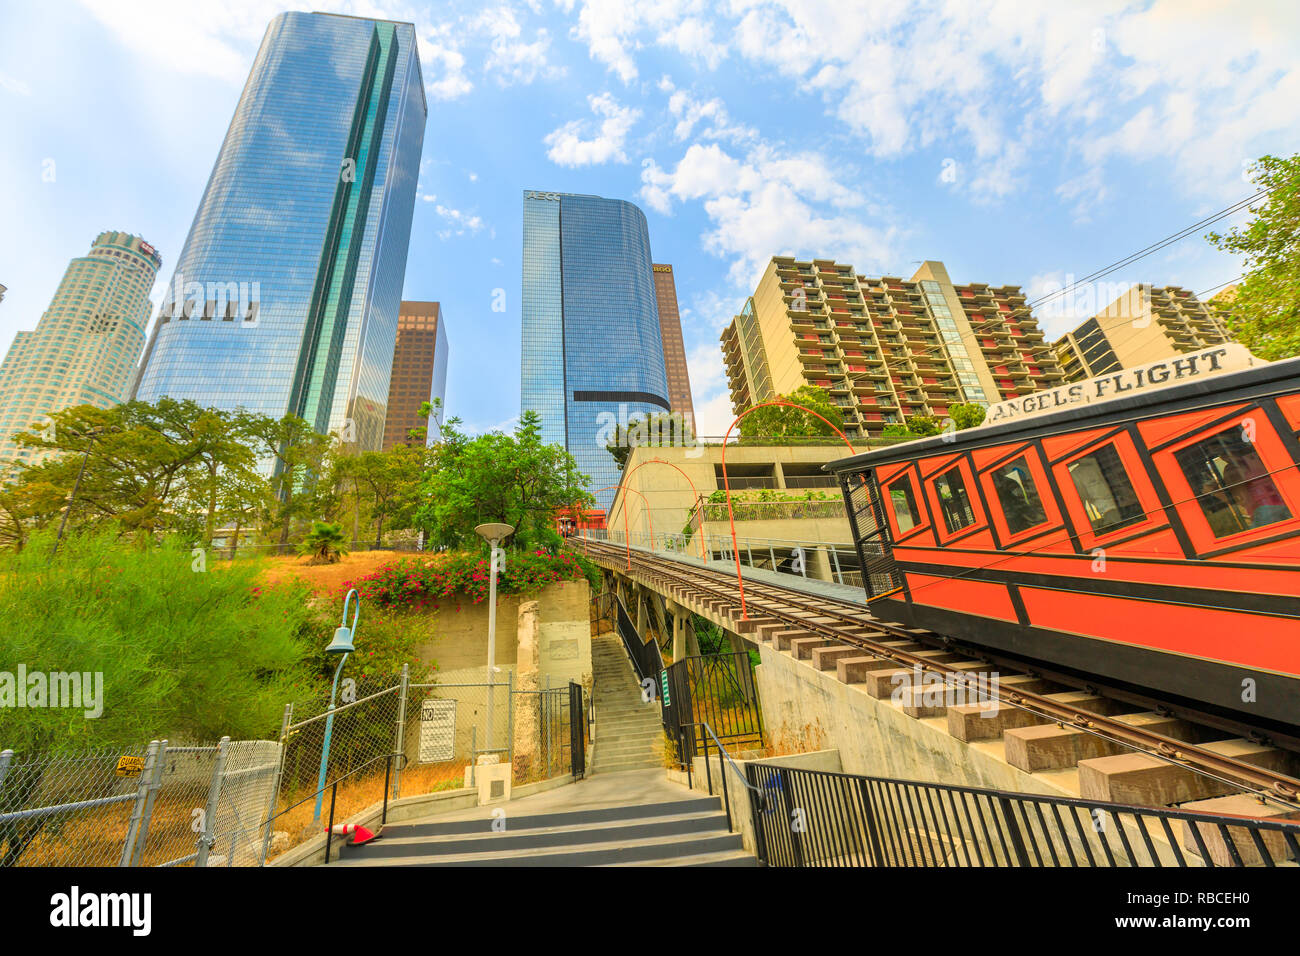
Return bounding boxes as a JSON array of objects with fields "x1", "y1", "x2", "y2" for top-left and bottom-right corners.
[{"x1": 1053, "y1": 285, "x2": 1232, "y2": 381}]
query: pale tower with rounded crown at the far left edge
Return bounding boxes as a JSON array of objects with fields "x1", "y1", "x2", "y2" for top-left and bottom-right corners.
[{"x1": 0, "y1": 232, "x2": 163, "y2": 473}]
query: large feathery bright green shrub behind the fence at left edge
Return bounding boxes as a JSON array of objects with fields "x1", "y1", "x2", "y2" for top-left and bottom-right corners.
[{"x1": 0, "y1": 533, "x2": 308, "y2": 752}]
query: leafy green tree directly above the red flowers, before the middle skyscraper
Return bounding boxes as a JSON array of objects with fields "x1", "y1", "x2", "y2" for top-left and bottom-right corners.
[{"x1": 415, "y1": 411, "x2": 594, "y2": 548}]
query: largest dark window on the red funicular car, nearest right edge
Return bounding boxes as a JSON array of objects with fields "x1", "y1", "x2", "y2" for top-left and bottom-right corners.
[{"x1": 1174, "y1": 427, "x2": 1291, "y2": 537}]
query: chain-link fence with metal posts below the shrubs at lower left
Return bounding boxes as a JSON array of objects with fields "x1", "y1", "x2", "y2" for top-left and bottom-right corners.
[{"x1": 0, "y1": 671, "x2": 582, "y2": 866}]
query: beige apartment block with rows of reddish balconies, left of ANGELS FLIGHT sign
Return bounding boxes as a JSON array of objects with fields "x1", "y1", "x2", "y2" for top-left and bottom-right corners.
[{"x1": 722, "y1": 256, "x2": 1062, "y2": 440}]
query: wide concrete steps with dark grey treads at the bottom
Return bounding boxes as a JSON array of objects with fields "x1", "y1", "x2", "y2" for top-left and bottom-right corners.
[{"x1": 330, "y1": 770, "x2": 758, "y2": 866}]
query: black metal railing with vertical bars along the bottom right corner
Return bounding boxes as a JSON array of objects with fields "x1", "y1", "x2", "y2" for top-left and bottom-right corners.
[{"x1": 743, "y1": 761, "x2": 1300, "y2": 866}]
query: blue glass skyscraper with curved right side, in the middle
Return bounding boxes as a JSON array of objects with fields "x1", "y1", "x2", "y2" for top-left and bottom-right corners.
[{"x1": 521, "y1": 191, "x2": 671, "y2": 509}]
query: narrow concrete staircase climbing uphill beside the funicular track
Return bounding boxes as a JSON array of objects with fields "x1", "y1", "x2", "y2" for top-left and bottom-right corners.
[{"x1": 590, "y1": 633, "x2": 663, "y2": 774}]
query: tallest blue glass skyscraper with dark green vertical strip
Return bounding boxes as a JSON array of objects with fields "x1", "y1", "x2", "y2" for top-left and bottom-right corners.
[{"x1": 134, "y1": 13, "x2": 428, "y2": 450}]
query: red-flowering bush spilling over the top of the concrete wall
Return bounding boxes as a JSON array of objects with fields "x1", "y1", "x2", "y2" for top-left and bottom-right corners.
[{"x1": 339, "y1": 550, "x2": 598, "y2": 610}]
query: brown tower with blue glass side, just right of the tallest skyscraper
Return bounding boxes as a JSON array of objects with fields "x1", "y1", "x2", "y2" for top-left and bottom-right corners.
[{"x1": 384, "y1": 302, "x2": 447, "y2": 451}]
